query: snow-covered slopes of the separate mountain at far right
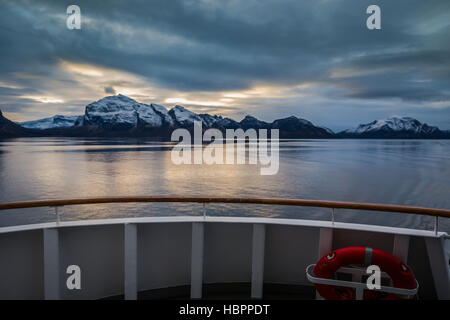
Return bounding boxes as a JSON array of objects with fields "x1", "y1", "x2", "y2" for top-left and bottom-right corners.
[{"x1": 343, "y1": 117, "x2": 439, "y2": 134}]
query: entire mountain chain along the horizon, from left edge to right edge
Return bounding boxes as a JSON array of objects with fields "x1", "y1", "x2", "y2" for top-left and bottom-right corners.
[{"x1": 7, "y1": 94, "x2": 450, "y2": 139}]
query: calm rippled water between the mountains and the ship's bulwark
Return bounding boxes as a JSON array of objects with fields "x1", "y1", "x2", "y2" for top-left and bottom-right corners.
[{"x1": 0, "y1": 138, "x2": 450, "y2": 232}]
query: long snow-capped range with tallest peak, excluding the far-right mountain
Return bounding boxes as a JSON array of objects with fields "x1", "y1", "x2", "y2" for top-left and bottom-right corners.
[{"x1": 1, "y1": 94, "x2": 336, "y2": 138}]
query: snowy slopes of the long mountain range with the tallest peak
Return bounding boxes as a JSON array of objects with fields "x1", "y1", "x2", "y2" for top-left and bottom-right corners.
[{"x1": 16, "y1": 94, "x2": 334, "y2": 136}]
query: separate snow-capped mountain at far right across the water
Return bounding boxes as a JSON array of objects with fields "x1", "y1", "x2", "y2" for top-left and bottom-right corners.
[{"x1": 339, "y1": 116, "x2": 446, "y2": 138}]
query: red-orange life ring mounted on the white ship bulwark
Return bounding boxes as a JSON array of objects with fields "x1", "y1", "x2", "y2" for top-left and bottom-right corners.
[{"x1": 314, "y1": 247, "x2": 416, "y2": 300}]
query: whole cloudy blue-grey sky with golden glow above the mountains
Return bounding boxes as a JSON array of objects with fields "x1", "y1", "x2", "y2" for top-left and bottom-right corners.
[{"x1": 0, "y1": 0, "x2": 450, "y2": 130}]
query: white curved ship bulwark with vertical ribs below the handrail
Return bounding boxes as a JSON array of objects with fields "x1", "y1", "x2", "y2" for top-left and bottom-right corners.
[{"x1": 0, "y1": 198, "x2": 450, "y2": 299}]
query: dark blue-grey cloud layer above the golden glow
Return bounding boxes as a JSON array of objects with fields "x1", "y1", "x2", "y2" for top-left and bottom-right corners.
[{"x1": 0, "y1": 0, "x2": 450, "y2": 127}]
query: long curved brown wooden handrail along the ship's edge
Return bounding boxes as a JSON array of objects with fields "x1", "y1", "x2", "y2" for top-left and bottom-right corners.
[{"x1": 0, "y1": 196, "x2": 450, "y2": 218}]
